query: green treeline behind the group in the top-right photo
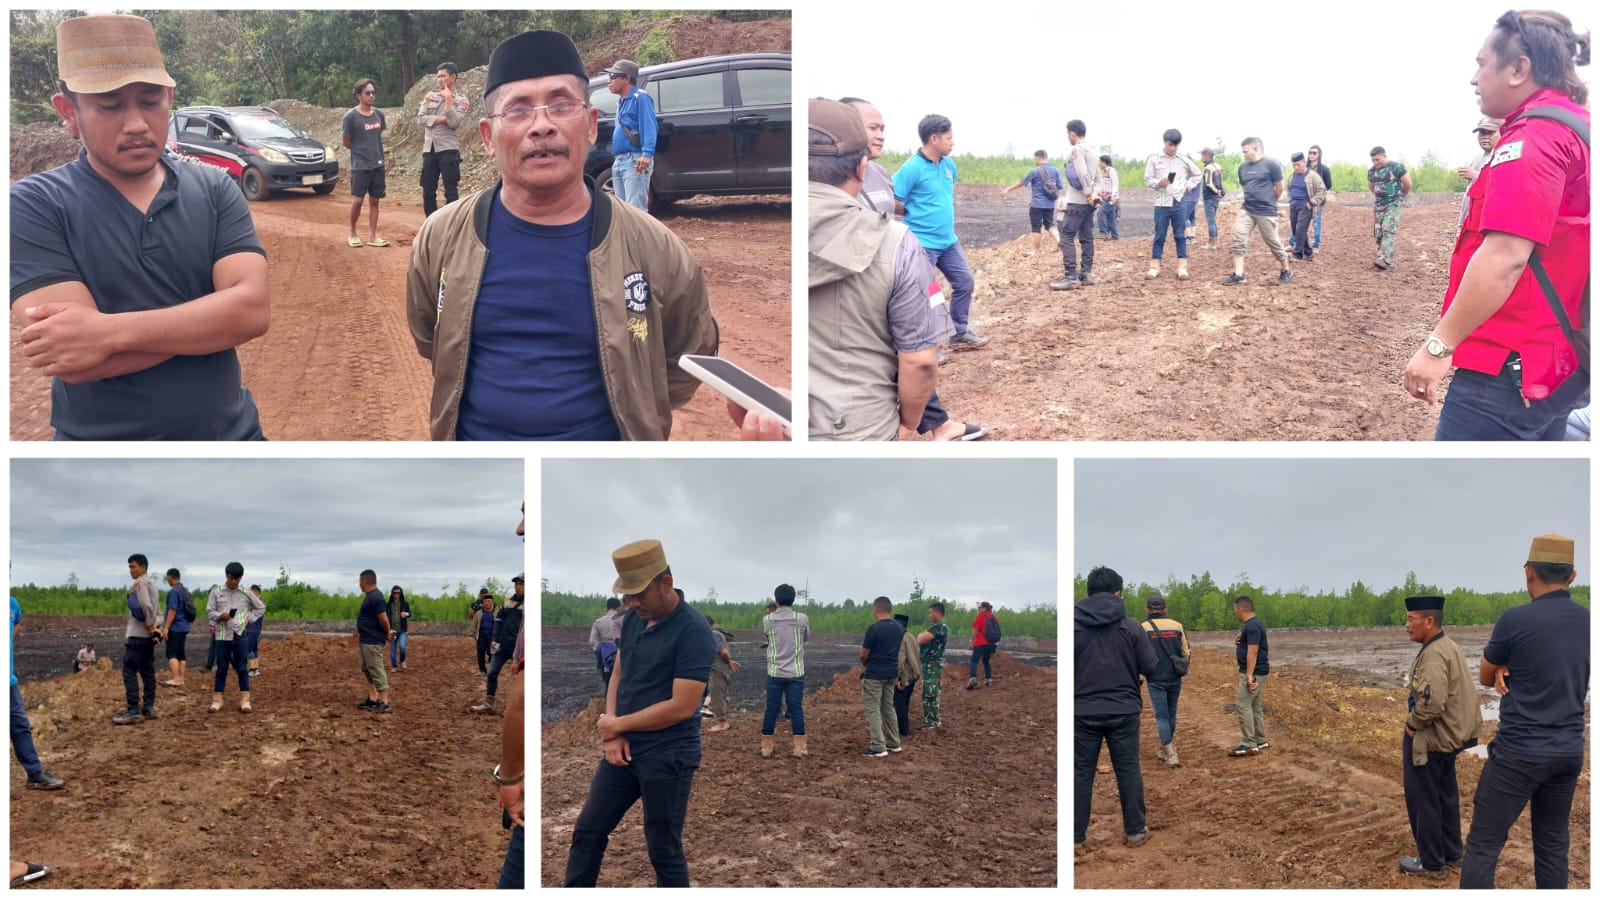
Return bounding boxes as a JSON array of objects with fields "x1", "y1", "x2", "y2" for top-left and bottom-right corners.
[{"x1": 878, "y1": 141, "x2": 1477, "y2": 197}]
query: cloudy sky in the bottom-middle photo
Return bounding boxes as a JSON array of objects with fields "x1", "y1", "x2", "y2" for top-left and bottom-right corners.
[{"x1": 541, "y1": 459, "x2": 1056, "y2": 608}]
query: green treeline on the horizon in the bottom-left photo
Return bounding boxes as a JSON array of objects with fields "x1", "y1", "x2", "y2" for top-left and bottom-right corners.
[{"x1": 11, "y1": 571, "x2": 510, "y2": 621}]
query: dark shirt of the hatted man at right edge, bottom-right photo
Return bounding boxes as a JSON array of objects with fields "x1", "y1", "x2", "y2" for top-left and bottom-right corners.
[{"x1": 1483, "y1": 590, "x2": 1589, "y2": 757}]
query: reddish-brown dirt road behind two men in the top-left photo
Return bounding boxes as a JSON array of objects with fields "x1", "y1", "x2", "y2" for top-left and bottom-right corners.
[{"x1": 11, "y1": 192, "x2": 790, "y2": 440}]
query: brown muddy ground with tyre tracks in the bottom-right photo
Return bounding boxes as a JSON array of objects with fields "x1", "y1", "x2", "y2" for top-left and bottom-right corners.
[{"x1": 1072, "y1": 627, "x2": 1590, "y2": 889}]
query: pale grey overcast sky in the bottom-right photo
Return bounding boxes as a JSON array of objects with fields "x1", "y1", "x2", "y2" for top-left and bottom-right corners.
[{"x1": 1072, "y1": 459, "x2": 1592, "y2": 592}]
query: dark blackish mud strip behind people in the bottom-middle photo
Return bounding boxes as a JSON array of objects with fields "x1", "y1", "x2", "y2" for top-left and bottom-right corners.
[{"x1": 539, "y1": 625, "x2": 1056, "y2": 725}]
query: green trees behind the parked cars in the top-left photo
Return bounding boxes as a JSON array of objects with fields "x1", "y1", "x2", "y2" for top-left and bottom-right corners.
[{"x1": 10, "y1": 10, "x2": 789, "y2": 125}]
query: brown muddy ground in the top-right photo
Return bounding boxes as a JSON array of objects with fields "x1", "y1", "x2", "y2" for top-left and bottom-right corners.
[{"x1": 939, "y1": 184, "x2": 1459, "y2": 440}]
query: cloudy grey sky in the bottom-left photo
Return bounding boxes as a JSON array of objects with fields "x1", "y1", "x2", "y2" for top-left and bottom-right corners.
[{"x1": 11, "y1": 459, "x2": 525, "y2": 595}]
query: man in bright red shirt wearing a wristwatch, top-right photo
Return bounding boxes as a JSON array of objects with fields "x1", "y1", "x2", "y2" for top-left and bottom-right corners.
[{"x1": 1403, "y1": 11, "x2": 1589, "y2": 440}]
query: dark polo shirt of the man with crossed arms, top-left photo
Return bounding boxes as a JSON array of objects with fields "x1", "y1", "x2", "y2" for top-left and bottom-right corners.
[{"x1": 11, "y1": 150, "x2": 266, "y2": 440}]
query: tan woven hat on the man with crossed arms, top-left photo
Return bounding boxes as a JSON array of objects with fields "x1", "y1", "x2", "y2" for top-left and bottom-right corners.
[{"x1": 56, "y1": 16, "x2": 178, "y2": 94}]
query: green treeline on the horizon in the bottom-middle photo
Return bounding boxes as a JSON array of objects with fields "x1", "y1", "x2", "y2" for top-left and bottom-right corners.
[{"x1": 539, "y1": 581, "x2": 1056, "y2": 640}]
